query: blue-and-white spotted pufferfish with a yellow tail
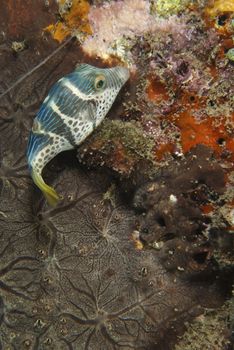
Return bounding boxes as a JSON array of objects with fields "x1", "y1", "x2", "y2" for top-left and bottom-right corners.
[{"x1": 27, "y1": 64, "x2": 129, "y2": 206}]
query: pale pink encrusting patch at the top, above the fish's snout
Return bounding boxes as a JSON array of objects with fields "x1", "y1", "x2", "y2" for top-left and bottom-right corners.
[{"x1": 83, "y1": 0, "x2": 185, "y2": 57}]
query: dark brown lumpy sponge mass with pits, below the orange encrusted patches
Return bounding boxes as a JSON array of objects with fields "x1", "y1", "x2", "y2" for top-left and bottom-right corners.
[{"x1": 133, "y1": 146, "x2": 225, "y2": 272}]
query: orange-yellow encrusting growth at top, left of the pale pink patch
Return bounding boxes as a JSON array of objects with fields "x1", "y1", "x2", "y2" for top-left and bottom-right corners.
[{"x1": 45, "y1": 0, "x2": 92, "y2": 42}]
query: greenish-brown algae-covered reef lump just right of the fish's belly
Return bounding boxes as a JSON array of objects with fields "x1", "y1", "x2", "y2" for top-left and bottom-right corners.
[{"x1": 77, "y1": 120, "x2": 154, "y2": 176}]
